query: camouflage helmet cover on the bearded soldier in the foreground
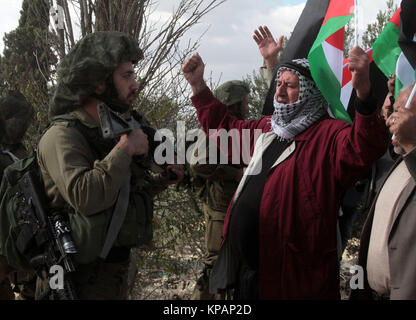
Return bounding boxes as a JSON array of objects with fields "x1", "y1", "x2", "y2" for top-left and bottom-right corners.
[{"x1": 49, "y1": 31, "x2": 143, "y2": 117}]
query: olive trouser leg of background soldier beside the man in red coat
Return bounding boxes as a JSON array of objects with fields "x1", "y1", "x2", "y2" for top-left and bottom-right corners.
[{"x1": 191, "y1": 204, "x2": 225, "y2": 300}]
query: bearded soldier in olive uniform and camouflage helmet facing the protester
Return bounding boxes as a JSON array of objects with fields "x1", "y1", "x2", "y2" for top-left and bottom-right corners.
[{"x1": 37, "y1": 32, "x2": 183, "y2": 300}]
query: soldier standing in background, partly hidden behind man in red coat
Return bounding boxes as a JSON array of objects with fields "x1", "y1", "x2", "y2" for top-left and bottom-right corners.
[{"x1": 191, "y1": 80, "x2": 250, "y2": 300}]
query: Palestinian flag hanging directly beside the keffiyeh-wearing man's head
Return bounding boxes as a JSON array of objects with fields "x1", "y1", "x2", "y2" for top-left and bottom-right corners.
[{"x1": 308, "y1": 0, "x2": 355, "y2": 123}]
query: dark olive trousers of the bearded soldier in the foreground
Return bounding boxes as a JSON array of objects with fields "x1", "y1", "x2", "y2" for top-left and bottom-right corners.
[{"x1": 36, "y1": 250, "x2": 137, "y2": 300}]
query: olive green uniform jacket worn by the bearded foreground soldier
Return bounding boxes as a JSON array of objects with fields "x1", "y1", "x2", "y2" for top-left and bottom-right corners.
[{"x1": 38, "y1": 109, "x2": 165, "y2": 263}]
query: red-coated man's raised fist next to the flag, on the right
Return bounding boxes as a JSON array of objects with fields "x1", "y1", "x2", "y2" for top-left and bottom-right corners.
[{"x1": 348, "y1": 47, "x2": 371, "y2": 101}]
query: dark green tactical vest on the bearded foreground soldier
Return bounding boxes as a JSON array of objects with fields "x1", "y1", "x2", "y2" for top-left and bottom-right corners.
[{"x1": 48, "y1": 115, "x2": 154, "y2": 264}]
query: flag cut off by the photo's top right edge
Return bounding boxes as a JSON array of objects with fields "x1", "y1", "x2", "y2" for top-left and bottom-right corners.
[{"x1": 396, "y1": 0, "x2": 416, "y2": 96}]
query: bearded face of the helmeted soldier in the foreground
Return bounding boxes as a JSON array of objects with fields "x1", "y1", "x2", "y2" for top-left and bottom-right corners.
[{"x1": 113, "y1": 62, "x2": 139, "y2": 105}]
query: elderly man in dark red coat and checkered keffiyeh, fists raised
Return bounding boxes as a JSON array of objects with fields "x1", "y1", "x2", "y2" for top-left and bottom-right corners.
[{"x1": 182, "y1": 47, "x2": 387, "y2": 299}]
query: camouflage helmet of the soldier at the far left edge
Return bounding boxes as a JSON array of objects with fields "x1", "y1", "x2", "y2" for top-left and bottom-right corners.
[{"x1": 0, "y1": 91, "x2": 34, "y2": 144}]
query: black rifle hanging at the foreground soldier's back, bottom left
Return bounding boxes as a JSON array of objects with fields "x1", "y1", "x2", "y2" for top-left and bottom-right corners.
[{"x1": 18, "y1": 170, "x2": 77, "y2": 300}]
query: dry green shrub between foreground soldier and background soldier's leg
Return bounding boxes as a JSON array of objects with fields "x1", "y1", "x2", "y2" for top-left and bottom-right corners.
[{"x1": 133, "y1": 187, "x2": 205, "y2": 300}]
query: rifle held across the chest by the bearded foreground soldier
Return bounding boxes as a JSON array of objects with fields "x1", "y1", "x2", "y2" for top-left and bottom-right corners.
[{"x1": 98, "y1": 103, "x2": 178, "y2": 180}]
